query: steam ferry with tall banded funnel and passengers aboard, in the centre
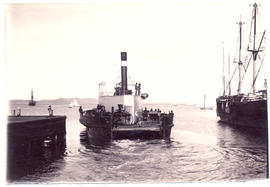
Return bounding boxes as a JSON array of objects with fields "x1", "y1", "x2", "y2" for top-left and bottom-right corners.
[{"x1": 79, "y1": 52, "x2": 174, "y2": 141}]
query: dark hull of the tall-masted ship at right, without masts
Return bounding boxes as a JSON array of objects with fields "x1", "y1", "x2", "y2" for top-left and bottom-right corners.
[{"x1": 217, "y1": 98, "x2": 268, "y2": 129}]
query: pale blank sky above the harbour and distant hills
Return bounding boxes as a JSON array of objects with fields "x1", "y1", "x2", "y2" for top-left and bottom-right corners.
[{"x1": 4, "y1": 0, "x2": 270, "y2": 105}]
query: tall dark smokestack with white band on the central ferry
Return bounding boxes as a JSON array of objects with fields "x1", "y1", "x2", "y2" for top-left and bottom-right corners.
[{"x1": 121, "y1": 52, "x2": 128, "y2": 95}]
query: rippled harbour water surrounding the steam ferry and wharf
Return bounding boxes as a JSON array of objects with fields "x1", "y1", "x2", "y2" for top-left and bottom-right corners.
[{"x1": 6, "y1": 103, "x2": 267, "y2": 183}]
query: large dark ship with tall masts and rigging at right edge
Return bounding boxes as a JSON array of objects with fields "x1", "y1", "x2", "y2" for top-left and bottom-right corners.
[{"x1": 216, "y1": 3, "x2": 268, "y2": 129}]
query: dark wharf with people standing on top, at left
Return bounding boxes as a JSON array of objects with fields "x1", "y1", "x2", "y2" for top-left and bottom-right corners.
[{"x1": 7, "y1": 115, "x2": 66, "y2": 181}]
